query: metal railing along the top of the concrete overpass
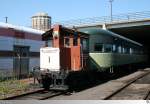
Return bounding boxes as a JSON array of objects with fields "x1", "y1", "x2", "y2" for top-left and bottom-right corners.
[{"x1": 53, "y1": 11, "x2": 150, "y2": 27}]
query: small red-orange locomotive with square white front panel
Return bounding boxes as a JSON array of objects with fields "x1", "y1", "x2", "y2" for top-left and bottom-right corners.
[{"x1": 40, "y1": 25, "x2": 88, "y2": 90}]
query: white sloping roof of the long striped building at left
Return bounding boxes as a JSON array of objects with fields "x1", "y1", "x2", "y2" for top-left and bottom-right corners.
[{"x1": 0, "y1": 22, "x2": 44, "y2": 35}]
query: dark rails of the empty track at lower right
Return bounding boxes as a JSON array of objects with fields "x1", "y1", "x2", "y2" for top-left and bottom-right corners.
[{"x1": 103, "y1": 71, "x2": 150, "y2": 100}]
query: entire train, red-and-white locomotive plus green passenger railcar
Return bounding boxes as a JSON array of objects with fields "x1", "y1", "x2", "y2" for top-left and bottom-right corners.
[{"x1": 37, "y1": 25, "x2": 146, "y2": 89}]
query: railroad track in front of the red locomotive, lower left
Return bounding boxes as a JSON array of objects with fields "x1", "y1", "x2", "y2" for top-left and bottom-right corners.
[{"x1": 2, "y1": 89, "x2": 65, "y2": 100}]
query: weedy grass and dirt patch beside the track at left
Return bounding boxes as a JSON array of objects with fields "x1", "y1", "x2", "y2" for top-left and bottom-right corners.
[{"x1": 0, "y1": 70, "x2": 41, "y2": 99}]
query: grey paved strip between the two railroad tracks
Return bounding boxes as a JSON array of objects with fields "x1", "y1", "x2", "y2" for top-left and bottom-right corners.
[{"x1": 51, "y1": 68, "x2": 149, "y2": 100}]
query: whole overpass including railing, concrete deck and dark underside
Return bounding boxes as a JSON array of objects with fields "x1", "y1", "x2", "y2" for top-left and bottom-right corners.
[{"x1": 54, "y1": 11, "x2": 150, "y2": 44}]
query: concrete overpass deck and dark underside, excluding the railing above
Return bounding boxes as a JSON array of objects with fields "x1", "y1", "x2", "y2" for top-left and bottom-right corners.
[{"x1": 76, "y1": 18, "x2": 150, "y2": 47}]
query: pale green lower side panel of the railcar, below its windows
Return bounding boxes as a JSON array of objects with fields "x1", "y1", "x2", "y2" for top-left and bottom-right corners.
[{"x1": 90, "y1": 53, "x2": 146, "y2": 68}]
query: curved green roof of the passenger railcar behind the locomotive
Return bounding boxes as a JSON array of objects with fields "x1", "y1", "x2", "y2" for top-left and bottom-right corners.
[{"x1": 79, "y1": 28, "x2": 143, "y2": 46}]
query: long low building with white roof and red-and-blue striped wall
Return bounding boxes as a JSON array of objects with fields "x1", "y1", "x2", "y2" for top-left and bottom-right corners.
[{"x1": 0, "y1": 22, "x2": 44, "y2": 75}]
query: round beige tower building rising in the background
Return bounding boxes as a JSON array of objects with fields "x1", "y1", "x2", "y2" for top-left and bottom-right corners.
[{"x1": 32, "y1": 13, "x2": 51, "y2": 31}]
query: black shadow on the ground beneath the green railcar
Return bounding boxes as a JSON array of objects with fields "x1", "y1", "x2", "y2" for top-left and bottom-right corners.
[{"x1": 66, "y1": 66, "x2": 148, "y2": 92}]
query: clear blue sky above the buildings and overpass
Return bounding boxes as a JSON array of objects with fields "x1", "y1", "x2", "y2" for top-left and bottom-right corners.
[{"x1": 0, "y1": 0, "x2": 150, "y2": 26}]
